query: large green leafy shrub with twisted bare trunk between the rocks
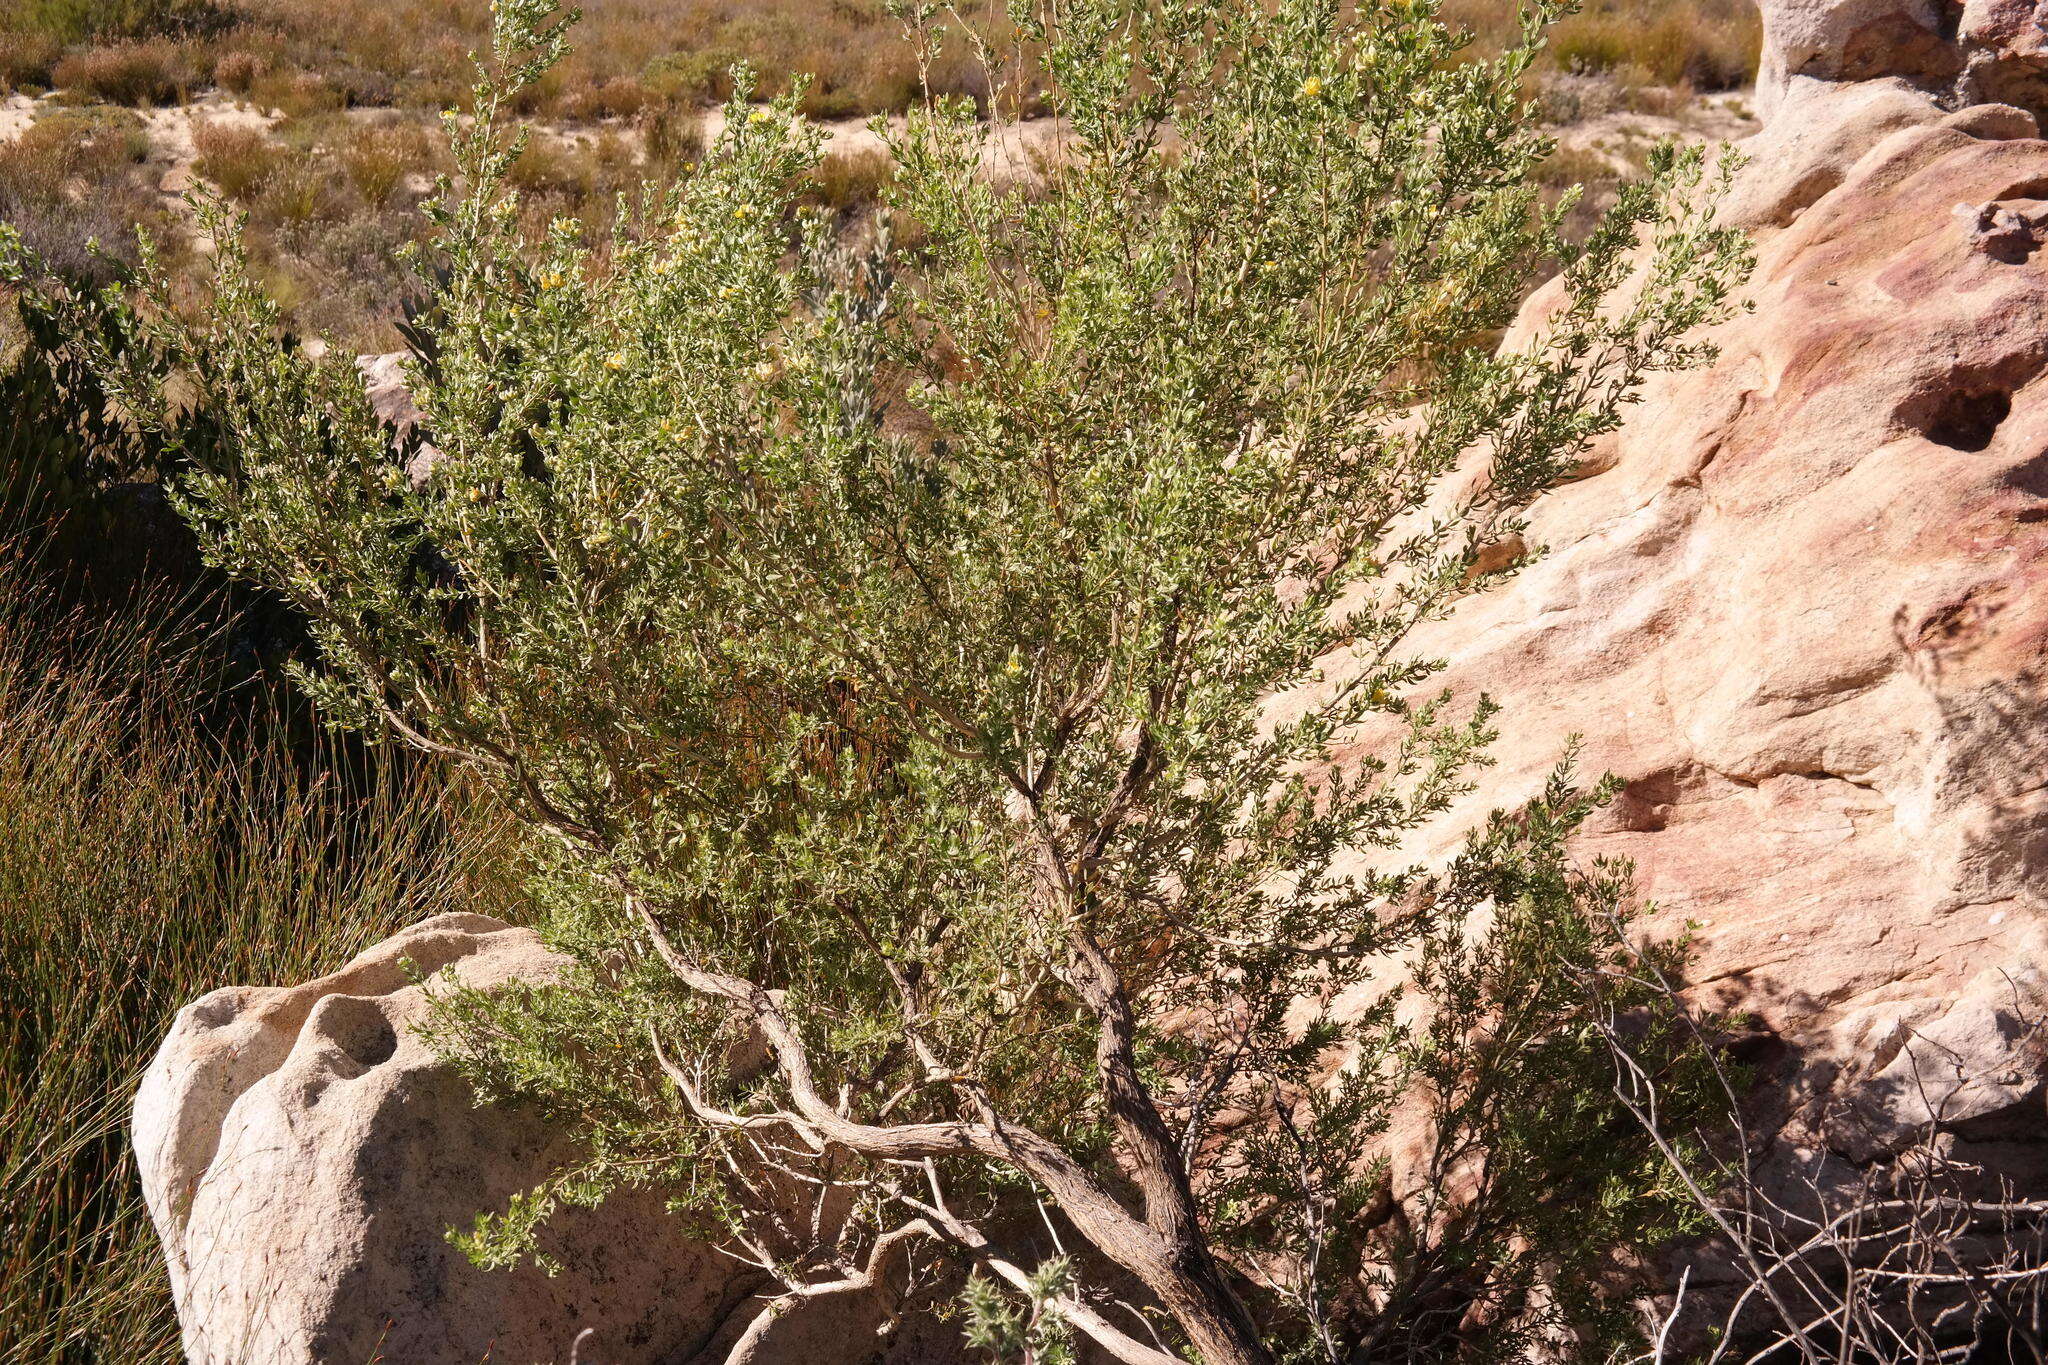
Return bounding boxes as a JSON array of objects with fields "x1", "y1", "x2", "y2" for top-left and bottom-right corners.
[{"x1": 72, "y1": 0, "x2": 1745, "y2": 1365}]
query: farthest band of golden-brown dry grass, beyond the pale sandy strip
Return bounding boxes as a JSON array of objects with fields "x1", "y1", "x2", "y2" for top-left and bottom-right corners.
[{"x1": 0, "y1": 0, "x2": 1761, "y2": 121}]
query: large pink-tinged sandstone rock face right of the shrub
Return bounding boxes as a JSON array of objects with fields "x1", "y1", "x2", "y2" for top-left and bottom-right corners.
[{"x1": 1318, "y1": 86, "x2": 2048, "y2": 1175}]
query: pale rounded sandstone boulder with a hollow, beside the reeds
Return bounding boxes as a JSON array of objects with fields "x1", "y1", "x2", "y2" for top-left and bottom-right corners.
[{"x1": 133, "y1": 915, "x2": 946, "y2": 1365}]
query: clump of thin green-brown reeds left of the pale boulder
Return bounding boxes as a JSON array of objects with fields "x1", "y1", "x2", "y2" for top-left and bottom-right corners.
[{"x1": 0, "y1": 557, "x2": 520, "y2": 1365}]
